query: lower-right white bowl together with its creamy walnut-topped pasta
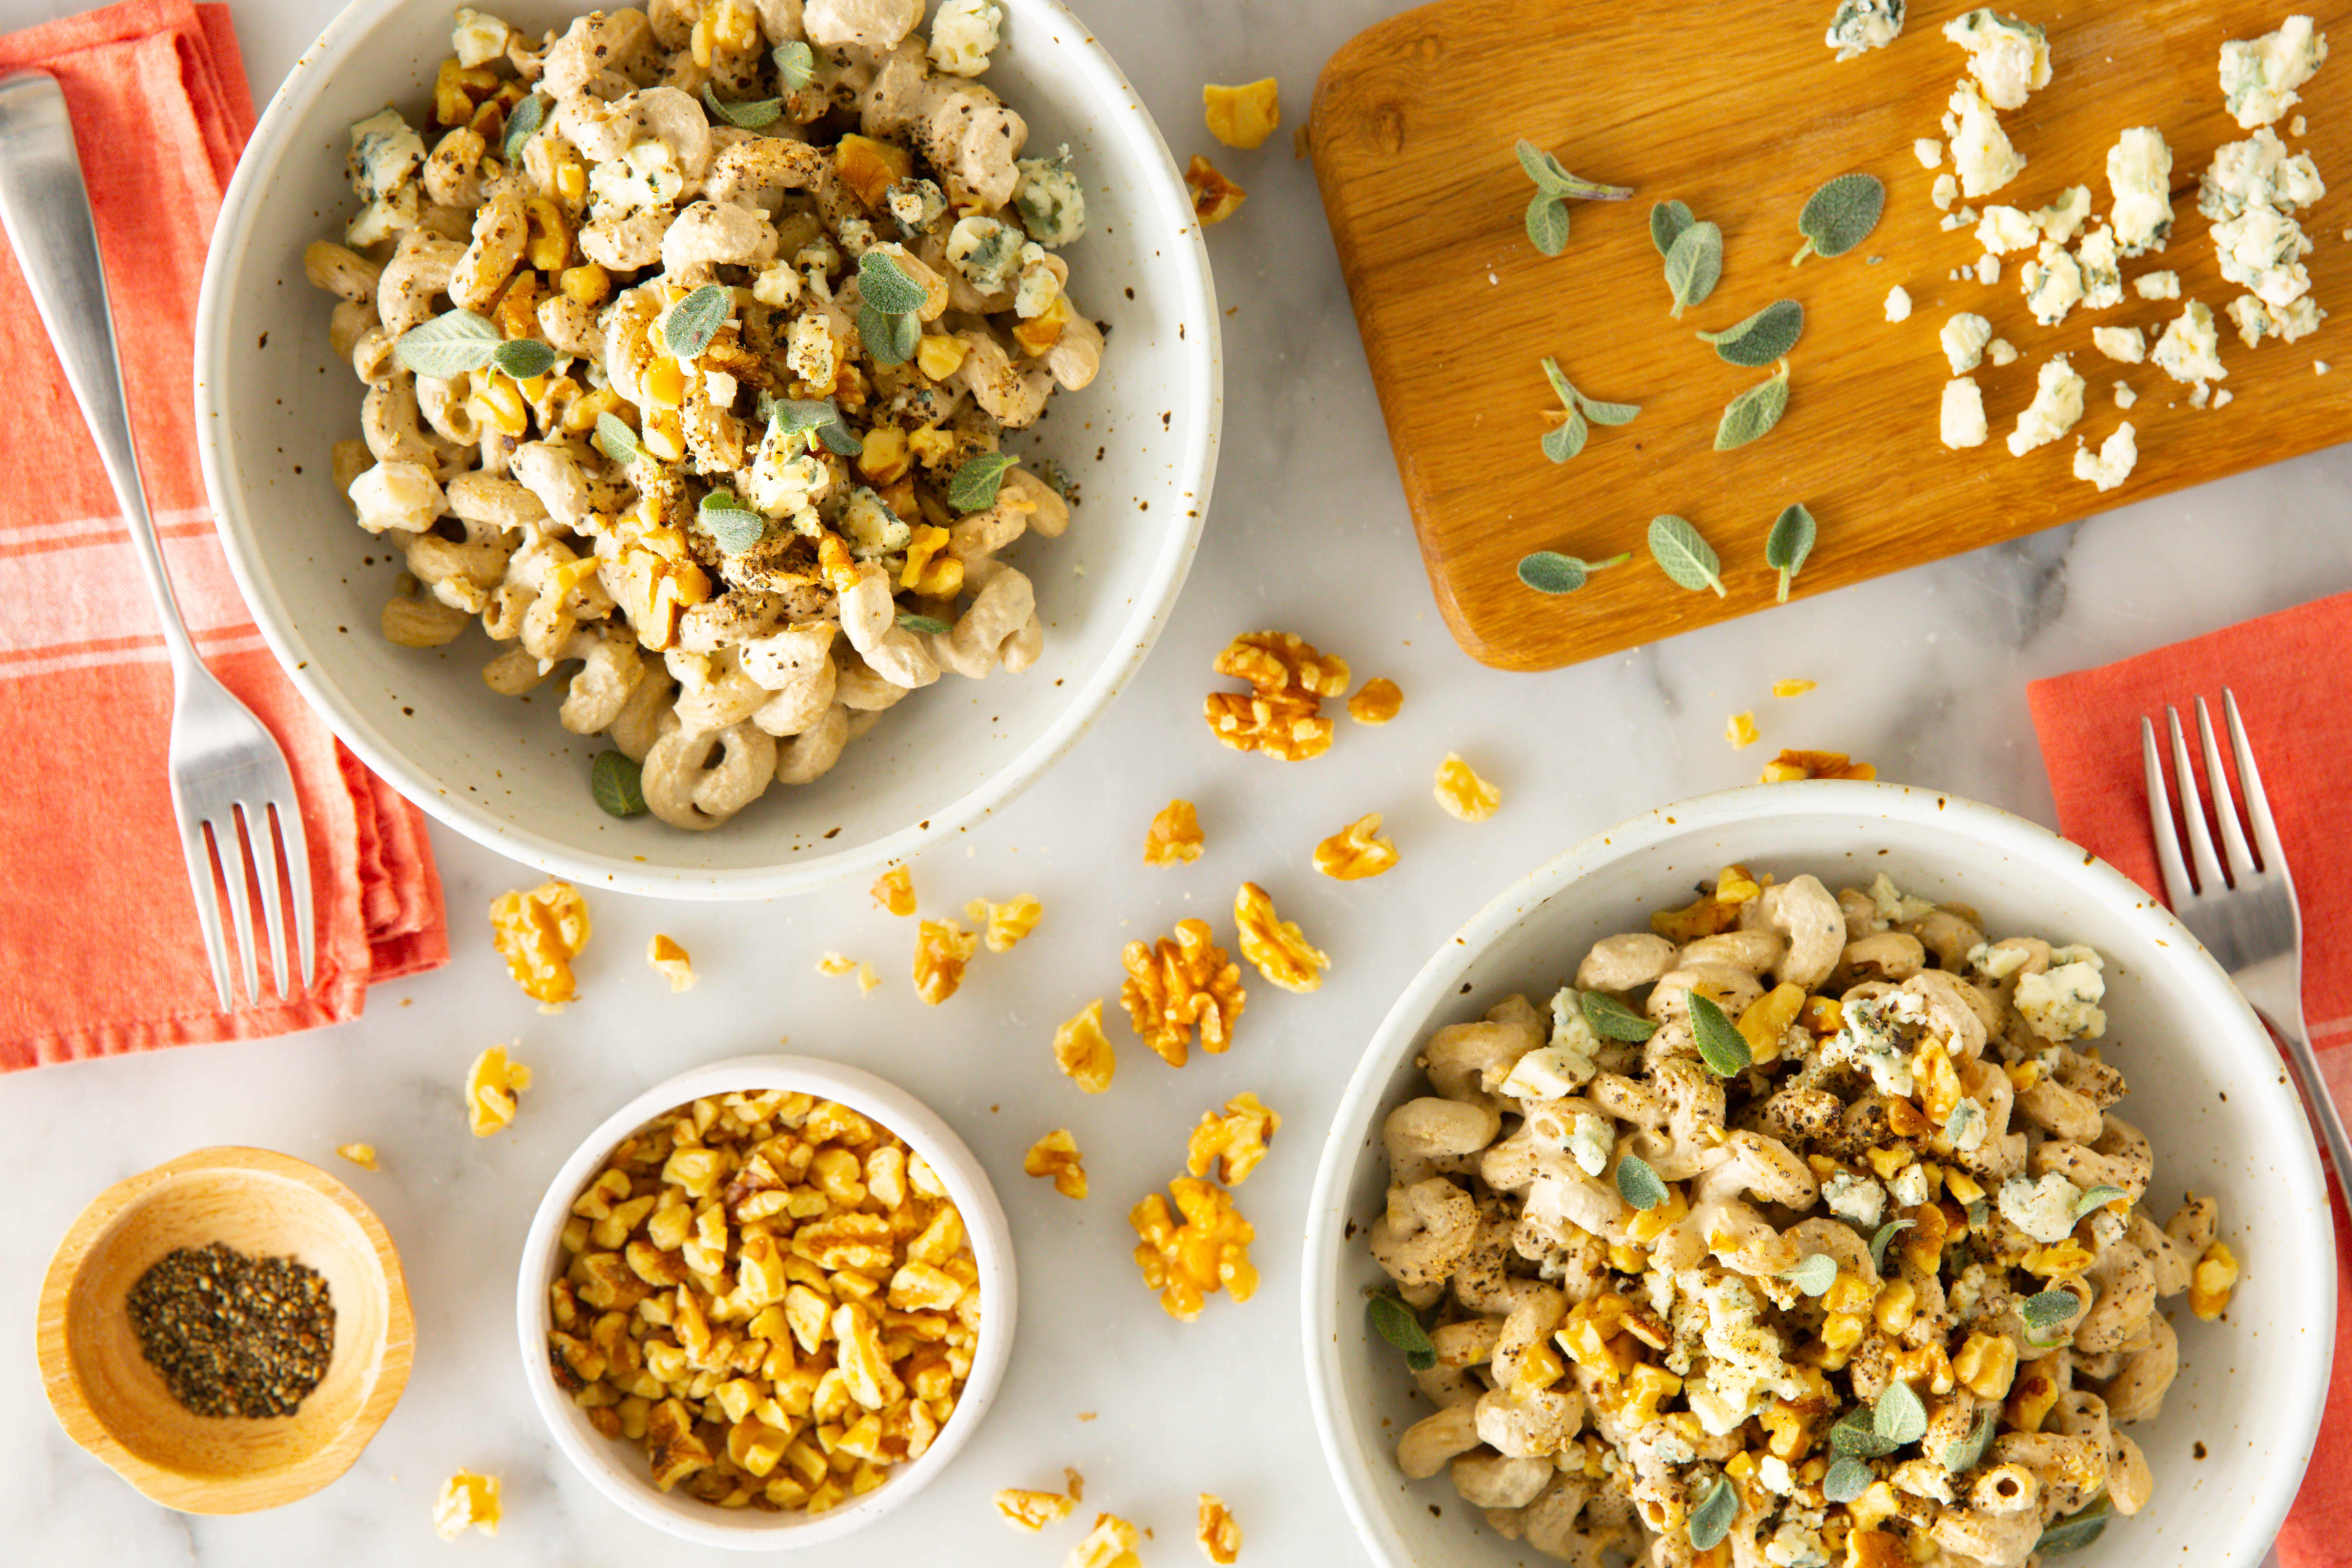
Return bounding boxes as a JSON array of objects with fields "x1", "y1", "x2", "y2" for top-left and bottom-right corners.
[{"x1": 1303, "y1": 781, "x2": 2336, "y2": 1568}]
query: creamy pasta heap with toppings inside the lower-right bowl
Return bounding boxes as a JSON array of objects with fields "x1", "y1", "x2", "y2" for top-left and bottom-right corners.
[{"x1": 1369, "y1": 865, "x2": 2237, "y2": 1568}]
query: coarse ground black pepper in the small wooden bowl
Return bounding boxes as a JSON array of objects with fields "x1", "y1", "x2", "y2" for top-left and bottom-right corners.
[{"x1": 127, "y1": 1241, "x2": 334, "y2": 1417}]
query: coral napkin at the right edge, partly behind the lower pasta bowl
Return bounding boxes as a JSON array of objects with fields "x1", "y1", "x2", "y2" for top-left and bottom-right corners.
[{"x1": 2027, "y1": 595, "x2": 2352, "y2": 1568}]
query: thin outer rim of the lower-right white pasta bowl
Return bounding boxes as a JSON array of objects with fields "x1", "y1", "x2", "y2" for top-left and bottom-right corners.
[{"x1": 1298, "y1": 781, "x2": 2336, "y2": 1568}]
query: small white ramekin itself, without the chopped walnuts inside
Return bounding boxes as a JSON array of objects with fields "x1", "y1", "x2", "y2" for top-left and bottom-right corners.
[{"x1": 515, "y1": 1056, "x2": 1018, "y2": 1552}]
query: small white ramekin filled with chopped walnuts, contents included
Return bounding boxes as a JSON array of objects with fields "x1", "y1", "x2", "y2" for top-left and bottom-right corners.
[{"x1": 515, "y1": 1056, "x2": 1016, "y2": 1547}]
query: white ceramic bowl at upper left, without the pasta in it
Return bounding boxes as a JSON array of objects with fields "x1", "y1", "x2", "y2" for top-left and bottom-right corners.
[{"x1": 195, "y1": 0, "x2": 1223, "y2": 898}]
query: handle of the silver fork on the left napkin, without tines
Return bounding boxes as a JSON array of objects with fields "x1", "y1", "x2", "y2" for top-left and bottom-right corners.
[{"x1": 0, "y1": 71, "x2": 198, "y2": 670}]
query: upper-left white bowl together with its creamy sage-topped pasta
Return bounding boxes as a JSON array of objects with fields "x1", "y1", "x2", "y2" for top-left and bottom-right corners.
[{"x1": 195, "y1": 0, "x2": 1221, "y2": 898}]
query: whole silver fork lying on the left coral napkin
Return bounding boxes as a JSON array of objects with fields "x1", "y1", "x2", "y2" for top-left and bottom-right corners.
[{"x1": 0, "y1": 71, "x2": 317, "y2": 1013}]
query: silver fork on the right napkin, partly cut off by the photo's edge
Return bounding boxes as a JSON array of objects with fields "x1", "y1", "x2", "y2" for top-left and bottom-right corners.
[{"x1": 2140, "y1": 689, "x2": 2352, "y2": 1185}]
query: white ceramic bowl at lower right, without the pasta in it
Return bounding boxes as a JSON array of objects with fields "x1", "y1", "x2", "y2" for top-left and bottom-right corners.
[{"x1": 1303, "y1": 783, "x2": 2336, "y2": 1568}]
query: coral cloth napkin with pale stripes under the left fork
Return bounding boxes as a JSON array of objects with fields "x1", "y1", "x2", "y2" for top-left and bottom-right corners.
[{"x1": 0, "y1": 0, "x2": 449, "y2": 1070}]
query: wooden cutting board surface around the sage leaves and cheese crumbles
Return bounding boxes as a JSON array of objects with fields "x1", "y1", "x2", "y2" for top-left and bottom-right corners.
[{"x1": 1312, "y1": 0, "x2": 2352, "y2": 670}]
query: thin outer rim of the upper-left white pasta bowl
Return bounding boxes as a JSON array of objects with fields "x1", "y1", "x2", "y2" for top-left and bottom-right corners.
[{"x1": 195, "y1": 0, "x2": 1226, "y2": 898}]
